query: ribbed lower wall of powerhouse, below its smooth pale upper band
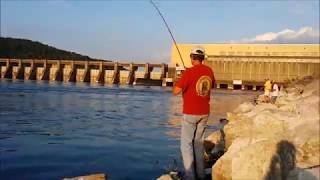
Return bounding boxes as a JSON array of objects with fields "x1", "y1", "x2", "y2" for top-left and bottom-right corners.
[{"x1": 205, "y1": 55, "x2": 320, "y2": 89}]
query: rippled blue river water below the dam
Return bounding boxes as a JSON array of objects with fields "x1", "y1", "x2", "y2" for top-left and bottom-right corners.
[{"x1": 0, "y1": 80, "x2": 256, "y2": 180}]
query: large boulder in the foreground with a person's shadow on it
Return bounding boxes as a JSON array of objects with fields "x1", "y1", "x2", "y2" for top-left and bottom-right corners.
[{"x1": 212, "y1": 138, "x2": 295, "y2": 180}]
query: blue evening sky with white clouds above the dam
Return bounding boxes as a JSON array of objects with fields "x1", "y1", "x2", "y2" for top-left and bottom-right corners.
[{"x1": 0, "y1": 0, "x2": 319, "y2": 63}]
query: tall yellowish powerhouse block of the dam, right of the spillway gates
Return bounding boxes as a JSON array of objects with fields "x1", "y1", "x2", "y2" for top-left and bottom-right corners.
[{"x1": 171, "y1": 44, "x2": 320, "y2": 90}]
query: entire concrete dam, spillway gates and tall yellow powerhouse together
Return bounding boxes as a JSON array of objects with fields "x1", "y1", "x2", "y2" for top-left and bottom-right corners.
[{"x1": 0, "y1": 44, "x2": 320, "y2": 90}]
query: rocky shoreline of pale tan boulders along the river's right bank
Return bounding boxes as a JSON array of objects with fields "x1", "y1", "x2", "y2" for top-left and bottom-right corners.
[{"x1": 206, "y1": 78, "x2": 320, "y2": 180}]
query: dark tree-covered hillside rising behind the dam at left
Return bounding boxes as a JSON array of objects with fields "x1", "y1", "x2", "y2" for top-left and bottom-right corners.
[{"x1": 0, "y1": 37, "x2": 101, "y2": 60}]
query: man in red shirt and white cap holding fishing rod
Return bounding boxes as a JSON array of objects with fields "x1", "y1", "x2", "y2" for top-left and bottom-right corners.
[{"x1": 172, "y1": 47, "x2": 215, "y2": 180}]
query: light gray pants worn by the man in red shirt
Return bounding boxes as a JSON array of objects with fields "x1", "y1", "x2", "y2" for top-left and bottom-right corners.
[{"x1": 180, "y1": 114, "x2": 209, "y2": 180}]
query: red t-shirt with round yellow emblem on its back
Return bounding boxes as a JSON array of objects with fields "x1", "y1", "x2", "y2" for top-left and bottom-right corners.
[{"x1": 176, "y1": 64, "x2": 215, "y2": 115}]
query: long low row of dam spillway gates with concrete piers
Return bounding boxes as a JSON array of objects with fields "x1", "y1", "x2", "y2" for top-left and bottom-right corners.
[{"x1": 0, "y1": 59, "x2": 168, "y2": 85}]
